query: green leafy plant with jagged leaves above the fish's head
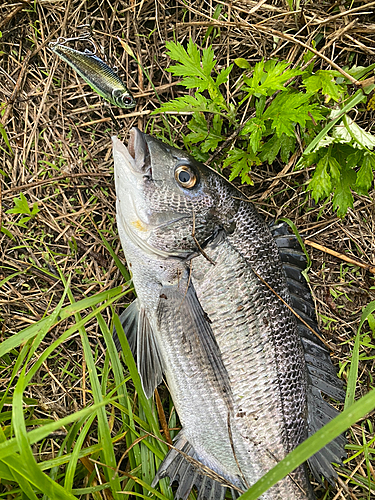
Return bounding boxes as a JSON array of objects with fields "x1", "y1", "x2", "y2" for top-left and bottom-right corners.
[{"x1": 154, "y1": 39, "x2": 375, "y2": 216}]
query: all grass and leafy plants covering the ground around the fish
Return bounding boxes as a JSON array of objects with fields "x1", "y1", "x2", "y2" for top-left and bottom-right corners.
[{"x1": 0, "y1": 0, "x2": 375, "y2": 500}]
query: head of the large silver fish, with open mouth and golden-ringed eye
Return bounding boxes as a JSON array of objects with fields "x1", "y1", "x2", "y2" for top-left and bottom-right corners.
[{"x1": 112, "y1": 128, "x2": 238, "y2": 258}]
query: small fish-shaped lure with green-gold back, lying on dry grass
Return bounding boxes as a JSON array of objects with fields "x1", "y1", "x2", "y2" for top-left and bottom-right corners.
[{"x1": 49, "y1": 42, "x2": 136, "y2": 109}]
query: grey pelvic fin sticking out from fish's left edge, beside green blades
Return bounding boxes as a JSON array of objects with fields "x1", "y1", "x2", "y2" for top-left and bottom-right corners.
[{"x1": 113, "y1": 299, "x2": 163, "y2": 398}]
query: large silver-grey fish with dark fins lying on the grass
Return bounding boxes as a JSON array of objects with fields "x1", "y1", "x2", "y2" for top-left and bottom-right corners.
[{"x1": 112, "y1": 128, "x2": 346, "y2": 500}]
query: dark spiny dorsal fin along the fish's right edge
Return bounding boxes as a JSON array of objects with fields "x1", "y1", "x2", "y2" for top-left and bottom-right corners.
[{"x1": 270, "y1": 222, "x2": 346, "y2": 485}]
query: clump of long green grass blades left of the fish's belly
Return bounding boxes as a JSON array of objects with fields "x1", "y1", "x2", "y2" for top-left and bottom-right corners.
[{"x1": 0, "y1": 277, "x2": 176, "y2": 500}]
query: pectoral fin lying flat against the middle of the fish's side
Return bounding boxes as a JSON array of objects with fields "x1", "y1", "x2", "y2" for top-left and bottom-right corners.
[{"x1": 157, "y1": 280, "x2": 232, "y2": 407}]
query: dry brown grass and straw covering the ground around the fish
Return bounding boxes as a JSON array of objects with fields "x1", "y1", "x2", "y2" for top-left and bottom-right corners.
[{"x1": 0, "y1": 0, "x2": 375, "y2": 499}]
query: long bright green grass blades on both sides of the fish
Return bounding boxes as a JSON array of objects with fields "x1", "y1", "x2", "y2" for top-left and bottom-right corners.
[{"x1": 0, "y1": 270, "x2": 375, "y2": 500}]
